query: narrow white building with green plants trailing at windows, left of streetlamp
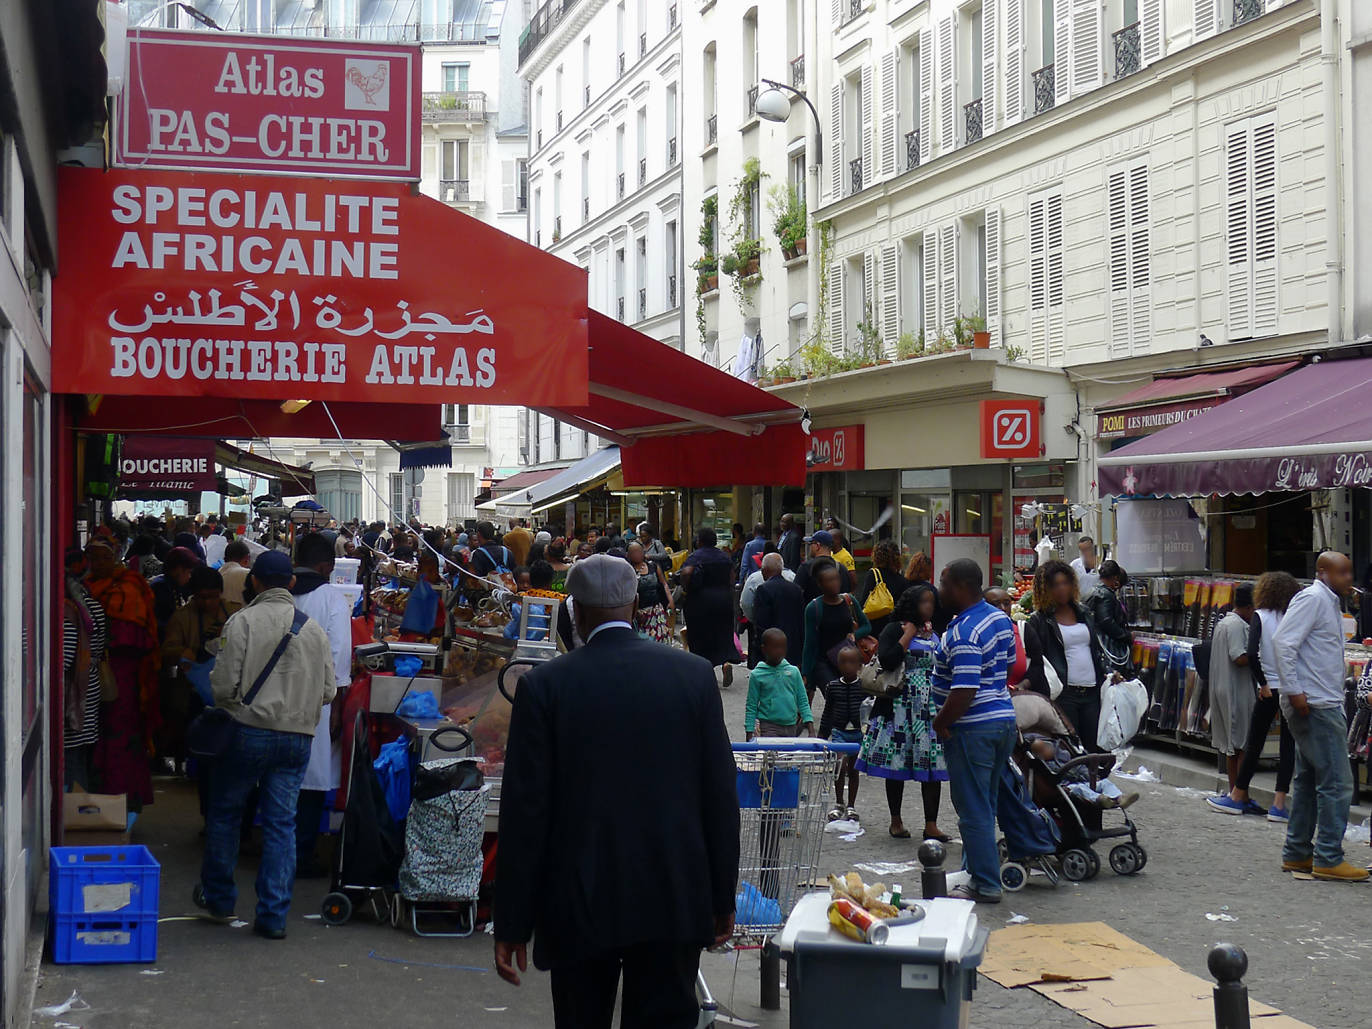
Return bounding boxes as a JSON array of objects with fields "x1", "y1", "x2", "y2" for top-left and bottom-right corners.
[{"x1": 682, "y1": 0, "x2": 819, "y2": 372}]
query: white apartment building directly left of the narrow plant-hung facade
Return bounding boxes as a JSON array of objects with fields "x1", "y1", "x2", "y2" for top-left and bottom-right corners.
[{"x1": 519, "y1": 0, "x2": 690, "y2": 465}]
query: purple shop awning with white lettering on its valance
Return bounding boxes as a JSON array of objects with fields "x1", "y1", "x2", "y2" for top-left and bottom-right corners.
[{"x1": 1098, "y1": 358, "x2": 1372, "y2": 497}]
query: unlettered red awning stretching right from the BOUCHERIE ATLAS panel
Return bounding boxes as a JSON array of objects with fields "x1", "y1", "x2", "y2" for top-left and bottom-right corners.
[{"x1": 541, "y1": 311, "x2": 808, "y2": 488}]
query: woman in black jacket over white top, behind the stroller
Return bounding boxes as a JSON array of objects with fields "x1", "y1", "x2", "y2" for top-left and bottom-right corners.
[{"x1": 1024, "y1": 560, "x2": 1107, "y2": 750}]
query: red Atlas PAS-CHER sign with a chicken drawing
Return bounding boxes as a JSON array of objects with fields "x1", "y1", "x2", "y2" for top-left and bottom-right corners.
[{"x1": 114, "y1": 29, "x2": 421, "y2": 181}]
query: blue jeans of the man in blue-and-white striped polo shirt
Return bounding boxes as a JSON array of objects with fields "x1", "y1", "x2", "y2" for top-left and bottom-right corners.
[{"x1": 944, "y1": 722, "x2": 1015, "y2": 897}]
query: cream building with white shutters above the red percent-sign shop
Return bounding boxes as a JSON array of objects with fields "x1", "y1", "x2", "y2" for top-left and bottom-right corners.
[{"x1": 781, "y1": 0, "x2": 1353, "y2": 565}]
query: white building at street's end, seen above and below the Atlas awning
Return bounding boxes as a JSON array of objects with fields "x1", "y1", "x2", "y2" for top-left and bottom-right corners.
[{"x1": 130, "y1": 0, "x2": 528, "y2": 524}]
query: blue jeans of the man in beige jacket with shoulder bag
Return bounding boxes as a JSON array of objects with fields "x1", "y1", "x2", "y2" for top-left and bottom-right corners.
[{"x1": 200, "y1": 726, "x2": 310, "y2": 929}]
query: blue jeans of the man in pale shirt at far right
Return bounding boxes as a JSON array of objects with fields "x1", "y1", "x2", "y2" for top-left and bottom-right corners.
[{"x1": 1281, "y1": 697, "x2": 1353, "y2": 868}]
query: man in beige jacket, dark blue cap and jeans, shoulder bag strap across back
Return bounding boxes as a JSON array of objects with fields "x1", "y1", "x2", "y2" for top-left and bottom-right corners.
[{"x1": 195, "y1": 550, "x2": 335, "y2": 940}]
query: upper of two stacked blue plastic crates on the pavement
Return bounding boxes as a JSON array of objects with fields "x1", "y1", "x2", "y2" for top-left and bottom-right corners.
[{"x1": 48, "y1": 847, "x2": 162, "y2": 923}]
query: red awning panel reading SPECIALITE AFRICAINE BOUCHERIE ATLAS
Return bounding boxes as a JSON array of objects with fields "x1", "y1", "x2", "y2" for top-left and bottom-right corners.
[{"x1": 54, "y1": 167, "x2": 587, "y2": 406}]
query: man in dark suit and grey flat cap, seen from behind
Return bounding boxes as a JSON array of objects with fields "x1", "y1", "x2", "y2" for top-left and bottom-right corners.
[{"x1": 495, "y1": 554, "x2": 738, "y2": 1029}]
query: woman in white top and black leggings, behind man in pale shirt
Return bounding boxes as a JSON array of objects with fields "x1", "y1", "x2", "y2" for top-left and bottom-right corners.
[{"x1": 1206, "y1": 572, "x2": 1301, "y2": 822}]
